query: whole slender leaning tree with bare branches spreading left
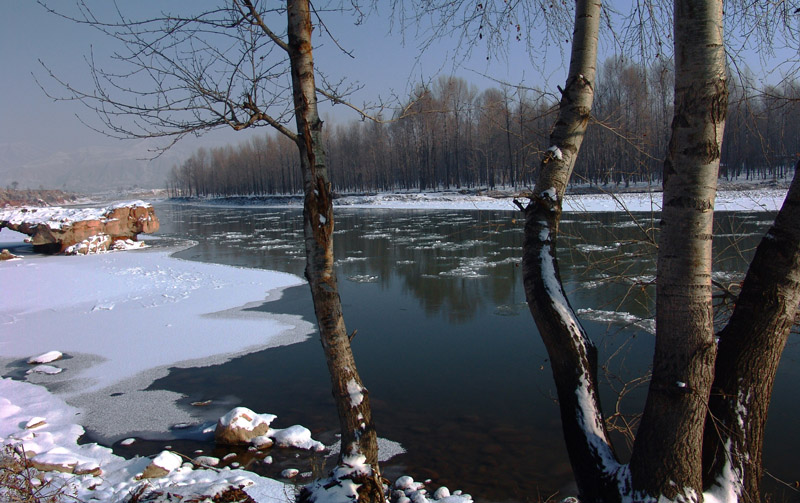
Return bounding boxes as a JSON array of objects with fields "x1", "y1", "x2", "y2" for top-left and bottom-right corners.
[{"x1": 38, "y1": 0, "x2": 384, "y2": 501}]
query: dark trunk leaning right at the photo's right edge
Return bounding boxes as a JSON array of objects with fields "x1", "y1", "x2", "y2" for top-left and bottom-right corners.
[{"x1": 703, "y1": 163, "x2": 800, "y2": 502}]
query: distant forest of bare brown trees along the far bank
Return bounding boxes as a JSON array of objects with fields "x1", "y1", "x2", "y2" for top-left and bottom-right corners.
[{"x1": 168, "y1": 58, "x2": 800, "y2": 196}]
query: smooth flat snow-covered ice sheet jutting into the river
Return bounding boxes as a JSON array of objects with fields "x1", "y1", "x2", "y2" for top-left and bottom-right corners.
[{"x1": 0, "y1": 238, "x2": 313, "y2": 441}]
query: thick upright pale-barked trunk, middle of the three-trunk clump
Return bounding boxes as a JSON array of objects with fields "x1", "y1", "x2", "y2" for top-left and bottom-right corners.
[{"x1": 630, "y1": 0, "x2": 728, "y2": 501}]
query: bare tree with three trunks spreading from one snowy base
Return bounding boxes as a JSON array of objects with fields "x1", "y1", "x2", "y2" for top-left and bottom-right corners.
[{"x1": 520, "y1": 0, "x2": 800, "y2": 501}]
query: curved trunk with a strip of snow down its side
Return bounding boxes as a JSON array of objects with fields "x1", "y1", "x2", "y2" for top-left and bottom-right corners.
[{"x1": 522, "y1": 0, "x2": 620, "y2": 501}]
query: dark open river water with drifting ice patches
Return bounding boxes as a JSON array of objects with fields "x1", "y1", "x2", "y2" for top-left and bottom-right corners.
[{"x1": 141, "y1": 204, "x2": 800, "y2": 501}]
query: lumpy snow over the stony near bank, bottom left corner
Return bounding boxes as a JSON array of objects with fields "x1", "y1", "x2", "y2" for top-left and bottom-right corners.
[{"x1": 0, "y1": 379, "x2": 291, "y2": 503}]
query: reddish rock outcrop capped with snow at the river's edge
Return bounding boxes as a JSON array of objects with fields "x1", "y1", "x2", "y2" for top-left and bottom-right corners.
[{"x1": 0, "y1": 201, "x2": 159, "y2": 253}]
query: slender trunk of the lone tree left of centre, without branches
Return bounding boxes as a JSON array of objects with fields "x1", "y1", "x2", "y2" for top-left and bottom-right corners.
[{"x1": 287, "y1": 0, "x2": 383, "y2": 501}]
